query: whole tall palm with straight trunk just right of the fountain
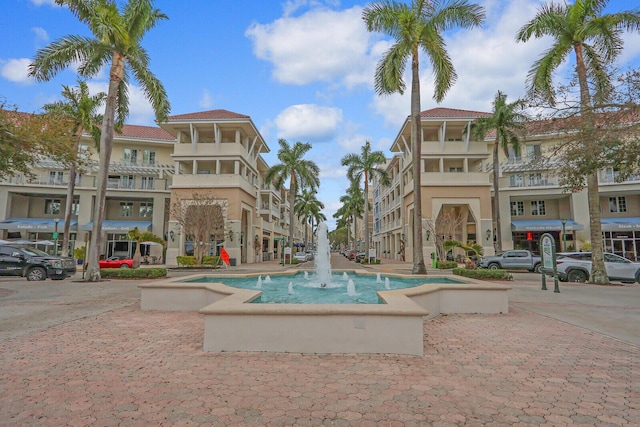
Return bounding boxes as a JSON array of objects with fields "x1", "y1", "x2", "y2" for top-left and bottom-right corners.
[{"x1": 363, "y1": 0, "x2": 485, "y2": 274}]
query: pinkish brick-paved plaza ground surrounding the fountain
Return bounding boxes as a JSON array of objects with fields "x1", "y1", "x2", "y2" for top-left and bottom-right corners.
[{"x1": 0, "y1": 255, "x2": 640, "y2": 426}]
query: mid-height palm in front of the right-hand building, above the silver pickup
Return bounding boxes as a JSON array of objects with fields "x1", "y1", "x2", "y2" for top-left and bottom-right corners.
[{"x1": 474, "y1": 91, "x2": 527, "y2": 252}]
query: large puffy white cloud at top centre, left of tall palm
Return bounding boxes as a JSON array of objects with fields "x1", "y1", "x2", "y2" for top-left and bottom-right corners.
[{"x1": 245, "y1": 6, "x2": 374, "y2": 87}]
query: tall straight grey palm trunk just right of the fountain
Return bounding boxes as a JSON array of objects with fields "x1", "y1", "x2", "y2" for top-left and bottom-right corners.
[{"x1": 411, "y1": 49, "x2": 427, "y2": 274}]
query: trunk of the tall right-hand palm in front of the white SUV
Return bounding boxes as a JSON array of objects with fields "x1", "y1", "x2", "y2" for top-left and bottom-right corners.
[{"x1": 574, "y1": 44, "x2": 609, "y2": 285}]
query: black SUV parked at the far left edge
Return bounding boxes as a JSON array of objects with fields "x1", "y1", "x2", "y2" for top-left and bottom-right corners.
[{"x1": 0, "y1": 245, "x2": 76, "y2": 280}]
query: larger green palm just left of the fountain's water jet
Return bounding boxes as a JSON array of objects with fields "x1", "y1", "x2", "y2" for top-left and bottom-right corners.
[{"x1": 265, "y1": 138, "x2": 320, "y2": 248}]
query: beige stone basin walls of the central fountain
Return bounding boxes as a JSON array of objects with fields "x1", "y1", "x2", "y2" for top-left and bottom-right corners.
[{"x1": 140, "y1": 271, "x2": 509, "y2": 356}]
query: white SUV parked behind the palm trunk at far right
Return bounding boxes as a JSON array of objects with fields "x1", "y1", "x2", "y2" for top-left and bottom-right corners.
[{"x1": 547, "y1": 252, "x2": 640, "y2": 283}]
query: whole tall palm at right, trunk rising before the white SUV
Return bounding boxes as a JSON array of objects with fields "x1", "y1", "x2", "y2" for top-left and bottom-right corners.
[{"x1": 516, "y1": 0, "x2": 640, "y2": 284}]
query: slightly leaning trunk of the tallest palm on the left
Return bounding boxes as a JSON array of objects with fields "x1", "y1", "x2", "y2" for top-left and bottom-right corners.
[{"x1": 87, "y1": 53, "x2": 125, "y2": 282}]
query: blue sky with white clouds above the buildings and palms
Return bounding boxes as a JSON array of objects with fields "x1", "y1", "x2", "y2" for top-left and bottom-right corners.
[{"x1": 0, "y1": 0, "x2": 640, "y2": 230}]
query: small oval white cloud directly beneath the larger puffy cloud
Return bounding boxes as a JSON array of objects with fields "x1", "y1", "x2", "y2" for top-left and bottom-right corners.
[{"x1": 274, "y1": 104, "x2": 342, "y2": 142}]
